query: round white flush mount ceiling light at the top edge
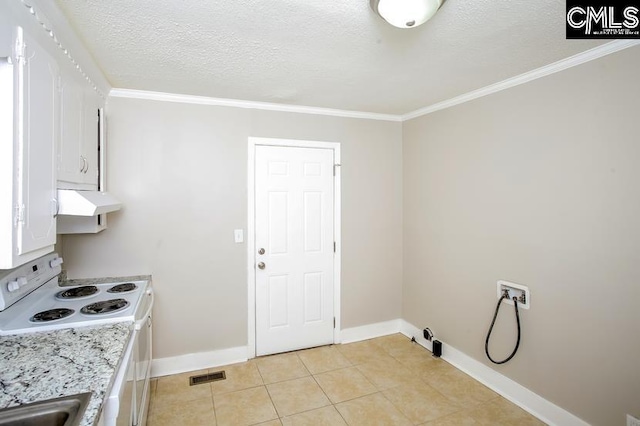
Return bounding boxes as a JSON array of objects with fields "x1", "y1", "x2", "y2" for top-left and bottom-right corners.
[{"x1": 370, "y1": 0, "x2": 445, "y2": 28}]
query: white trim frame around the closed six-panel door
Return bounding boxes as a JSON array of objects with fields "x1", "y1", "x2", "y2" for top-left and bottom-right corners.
[{"x1": 247, "y1": 136, "x2": 342, "y2": 358}]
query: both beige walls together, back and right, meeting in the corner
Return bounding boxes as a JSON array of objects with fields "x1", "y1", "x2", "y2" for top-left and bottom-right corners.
[{"x1": 62, "y1": 43, "x2": 640, "y2": 425}]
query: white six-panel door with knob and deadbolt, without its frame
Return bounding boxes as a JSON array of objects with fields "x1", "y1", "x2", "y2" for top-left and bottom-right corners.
[{"x1": 255, "y1": 146, "x2": 334, "y2": 355}]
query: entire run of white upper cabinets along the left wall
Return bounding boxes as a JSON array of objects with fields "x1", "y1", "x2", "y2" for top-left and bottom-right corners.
[{"x1": 0, "y1": 0, "x2": 109, "y2": 248}]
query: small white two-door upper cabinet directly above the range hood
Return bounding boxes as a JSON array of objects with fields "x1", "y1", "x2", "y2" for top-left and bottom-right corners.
[{"x1": 58, "y1": 73, "x2": 99, "y2": 190}]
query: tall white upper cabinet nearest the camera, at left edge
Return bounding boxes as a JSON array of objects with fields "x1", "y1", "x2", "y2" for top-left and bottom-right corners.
[{"x1": 0, "y1": 23, "x2": 59, "y2": 269}]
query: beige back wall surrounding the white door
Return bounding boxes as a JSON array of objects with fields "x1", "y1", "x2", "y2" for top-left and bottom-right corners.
[{"x1": 63, "y1": 98, "x2": 402, "y2": 358}]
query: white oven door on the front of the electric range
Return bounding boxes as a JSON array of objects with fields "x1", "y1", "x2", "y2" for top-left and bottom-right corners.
[{"x1": 133, "y1": 289, "x2": 153, "y2": 426}]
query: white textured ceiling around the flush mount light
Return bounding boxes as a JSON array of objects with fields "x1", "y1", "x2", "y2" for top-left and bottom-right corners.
[{"x1": 56, "y1": 0, "x2": 602, "y2": 114}]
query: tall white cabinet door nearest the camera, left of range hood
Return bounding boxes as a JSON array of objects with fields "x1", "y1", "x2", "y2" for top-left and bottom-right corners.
[{"x1": 17, "y1": 30, "x2": 58, "y2": 255}]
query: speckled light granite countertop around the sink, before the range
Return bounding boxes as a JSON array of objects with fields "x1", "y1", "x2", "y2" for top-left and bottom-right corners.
[{"x1": 0, "y1": 321, "x2": 133, "y2": 426}]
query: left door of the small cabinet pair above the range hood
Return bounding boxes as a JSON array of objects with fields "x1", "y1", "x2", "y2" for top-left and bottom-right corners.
[{"x1": 58, "y1": 75, "x2": 85, "y2": 182}]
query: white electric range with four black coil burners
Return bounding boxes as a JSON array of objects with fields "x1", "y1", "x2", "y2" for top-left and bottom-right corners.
[{"x1": 0, "y1": 253, "x2": 153, "y2": 426}]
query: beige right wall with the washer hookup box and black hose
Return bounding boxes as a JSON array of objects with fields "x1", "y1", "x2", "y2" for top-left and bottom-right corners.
[{"x1": 403, "y1": 47, "x2": 640, "y2": 426}]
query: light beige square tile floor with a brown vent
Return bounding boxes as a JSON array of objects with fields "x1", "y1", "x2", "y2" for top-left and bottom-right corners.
[{"x1": 147, "y1": 334, "x2": 544, "y2": 426}]
